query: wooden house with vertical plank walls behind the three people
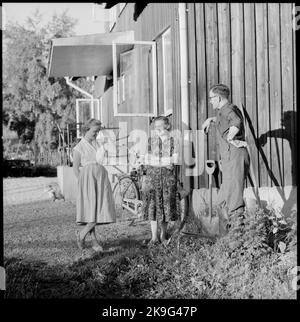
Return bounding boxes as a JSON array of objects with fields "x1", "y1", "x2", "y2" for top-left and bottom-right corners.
[{"x1": 50, "y1": 3, "x2": 297, "y2": 206}]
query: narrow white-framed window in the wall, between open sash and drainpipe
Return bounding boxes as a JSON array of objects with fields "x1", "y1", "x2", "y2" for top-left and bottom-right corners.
[{"x1": 156, "y1": 28, "x2": 174, "y2": 116}]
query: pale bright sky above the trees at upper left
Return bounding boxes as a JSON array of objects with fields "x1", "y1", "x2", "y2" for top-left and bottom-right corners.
[{"x1": 2, "y1": 2, "x2": 104, "y2": 35}]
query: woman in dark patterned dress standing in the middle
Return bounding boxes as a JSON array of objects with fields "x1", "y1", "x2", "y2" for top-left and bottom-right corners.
[{"x1": 142, "y1": 116, "x2": 180, "y2": 245}]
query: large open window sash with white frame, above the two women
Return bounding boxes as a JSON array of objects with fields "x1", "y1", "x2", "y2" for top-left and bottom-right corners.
[{"x1": 112, "y1": 41, "x2": 157, "y2": 117}]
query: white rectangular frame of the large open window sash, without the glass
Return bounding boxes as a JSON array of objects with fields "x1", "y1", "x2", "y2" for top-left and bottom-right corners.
[{"x1": 112, "y1": 41, "x2": 157, "y2": 117}]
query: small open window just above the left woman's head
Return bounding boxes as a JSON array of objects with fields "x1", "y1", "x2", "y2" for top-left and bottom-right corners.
[{"x1": 76, "y1": 98, "x2": 101, "y2": 138}]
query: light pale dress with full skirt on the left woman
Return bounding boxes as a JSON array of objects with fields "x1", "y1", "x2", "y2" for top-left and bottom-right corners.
[{"x1": 74, "y1": 138, "x2": 116, "y2": 224}]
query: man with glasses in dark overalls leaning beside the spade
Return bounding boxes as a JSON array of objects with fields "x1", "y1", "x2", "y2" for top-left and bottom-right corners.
[{"x1": 202, "y1": 84, "x2": 250, "y2": 228}]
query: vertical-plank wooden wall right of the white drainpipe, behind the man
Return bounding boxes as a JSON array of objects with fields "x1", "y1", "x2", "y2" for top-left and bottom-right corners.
[{"x1": 187, "y1": 3, "x2": 296, "y2": 187}]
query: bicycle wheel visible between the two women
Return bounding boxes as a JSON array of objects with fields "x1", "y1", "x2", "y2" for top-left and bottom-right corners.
[{"x1": 113, "y1": 176, "x2": 140, "y2": 220}]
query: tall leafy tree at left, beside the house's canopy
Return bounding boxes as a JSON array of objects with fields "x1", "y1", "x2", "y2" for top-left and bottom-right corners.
[{"x1": 3, "y1": 11, "x2": 89, "y2": 160}]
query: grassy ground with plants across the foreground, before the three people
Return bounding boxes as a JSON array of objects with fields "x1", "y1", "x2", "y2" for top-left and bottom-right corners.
[{"x1": 4, "y1": 178, "x2": 297, "y2": 299}]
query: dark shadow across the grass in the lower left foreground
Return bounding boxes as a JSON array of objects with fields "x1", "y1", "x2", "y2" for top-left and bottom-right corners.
[{"x1": 4, "y1": 239, "x2": 158, "y2": 299}]
